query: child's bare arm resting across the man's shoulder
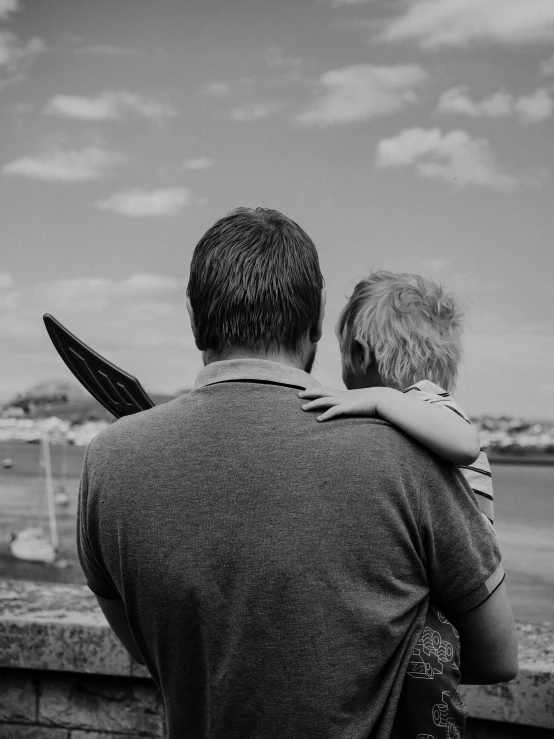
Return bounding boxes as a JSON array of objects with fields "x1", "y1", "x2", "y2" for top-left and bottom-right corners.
[{"x1": 298, "y1": 387, "x2": 480, "y2": 465}]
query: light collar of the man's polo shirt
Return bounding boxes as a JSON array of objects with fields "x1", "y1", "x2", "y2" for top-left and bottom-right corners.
[{"x1": 194, "y1": 359, "x2": 320, "y2": 388}]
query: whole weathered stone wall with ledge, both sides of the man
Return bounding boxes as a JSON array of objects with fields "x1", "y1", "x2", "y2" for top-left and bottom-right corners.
[{"x1": 0, "y1": 580, "x2": 554, "y2": 739}]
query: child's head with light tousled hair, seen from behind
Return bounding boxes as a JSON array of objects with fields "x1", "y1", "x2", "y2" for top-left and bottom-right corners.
[{"x1": 337, "y1": 270, "x2": 462, "y2": 390}]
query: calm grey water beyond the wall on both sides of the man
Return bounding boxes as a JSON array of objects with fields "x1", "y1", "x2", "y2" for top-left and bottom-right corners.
[{"x1": 0, "y1": 443, "x2": 554, "y2": 622}]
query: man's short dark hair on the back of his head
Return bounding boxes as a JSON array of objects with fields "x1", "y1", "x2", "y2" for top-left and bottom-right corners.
[{"x1": 187, "y1": 208, "x2": 323, "y2": 352}]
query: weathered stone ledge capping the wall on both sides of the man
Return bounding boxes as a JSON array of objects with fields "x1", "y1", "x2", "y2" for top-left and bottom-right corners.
[{"x1": 0, "y1": 580, "x2": 554, "y2": 729}]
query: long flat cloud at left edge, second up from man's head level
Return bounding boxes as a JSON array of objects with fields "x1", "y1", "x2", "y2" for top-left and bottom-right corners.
[{"x1": 2, "y1": 146, "x2": 125, "y2": 182}]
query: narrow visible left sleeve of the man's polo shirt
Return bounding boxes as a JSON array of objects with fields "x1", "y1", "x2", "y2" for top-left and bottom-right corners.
[{"x1": 77, "y1": 445, "x2": 121, "y2": 600}]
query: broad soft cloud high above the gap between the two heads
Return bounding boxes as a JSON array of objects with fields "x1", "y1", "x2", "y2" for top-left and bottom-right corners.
[{"x1": 297, "y1": 64, "x2": 428, "y2": 126}]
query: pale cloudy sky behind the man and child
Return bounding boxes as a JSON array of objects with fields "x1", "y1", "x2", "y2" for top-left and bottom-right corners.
[{"x1": 0, "y1": 0, "x2": 554, "y2": 417}]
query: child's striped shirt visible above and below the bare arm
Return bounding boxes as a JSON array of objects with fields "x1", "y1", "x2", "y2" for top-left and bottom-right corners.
[{"x1": 404, "y1": 380, "x2": 494, "y2": 523}]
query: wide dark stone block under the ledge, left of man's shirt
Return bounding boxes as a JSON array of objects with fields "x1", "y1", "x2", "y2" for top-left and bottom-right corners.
[{"x1": 38, "y1": 676, "x2": 164, "y2": 737}]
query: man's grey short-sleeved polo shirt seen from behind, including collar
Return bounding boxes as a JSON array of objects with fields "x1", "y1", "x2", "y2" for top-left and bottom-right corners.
[{"x1": 77, "y1": 360, "x2": 503, "y2": 739}]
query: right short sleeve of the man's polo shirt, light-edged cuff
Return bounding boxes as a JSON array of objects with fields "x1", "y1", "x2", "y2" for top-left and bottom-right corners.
[{"x1": 419, "y1": 457, "x2": 504, "y2": 616}]
